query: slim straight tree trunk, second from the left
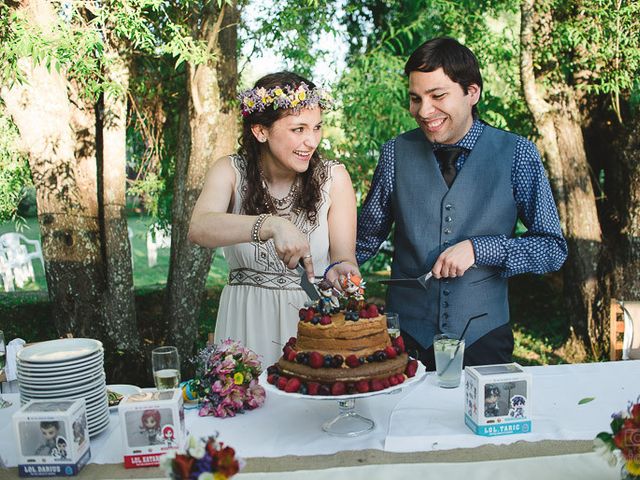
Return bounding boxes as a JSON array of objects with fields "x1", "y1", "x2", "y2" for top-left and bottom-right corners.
[{"x1": 97, "y1": 41, "x2": 144, "y2": 381}]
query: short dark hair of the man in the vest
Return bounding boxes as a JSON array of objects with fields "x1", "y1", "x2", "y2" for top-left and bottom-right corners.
[{"x1": 404, "y1": 37, "x2": 482, "y2": 116}]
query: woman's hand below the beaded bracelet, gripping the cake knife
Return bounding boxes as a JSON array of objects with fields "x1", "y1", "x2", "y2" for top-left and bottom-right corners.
[{"x1": 261, "y1": 216, "x2": 314, "y2": 278}]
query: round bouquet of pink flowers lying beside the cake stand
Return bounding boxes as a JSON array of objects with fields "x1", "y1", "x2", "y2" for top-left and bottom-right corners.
[{"x1": 190, "y1": 339, "x2": 265, "y2": 417}]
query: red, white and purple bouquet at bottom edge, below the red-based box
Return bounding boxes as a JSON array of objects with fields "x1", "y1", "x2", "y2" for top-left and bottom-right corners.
[{"x1": 160, "y1": 437, "x2": 240, "y2": 480}]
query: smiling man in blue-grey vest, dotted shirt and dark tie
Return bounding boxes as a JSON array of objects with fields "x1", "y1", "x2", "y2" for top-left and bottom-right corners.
[{"x1": 356, "y1": 38, "x2": 567, "y2": 369}]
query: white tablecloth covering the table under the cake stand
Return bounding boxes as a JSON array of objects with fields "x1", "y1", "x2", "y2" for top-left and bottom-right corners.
[{"x1": 0, "y1": 361, "x2": 640, "y2": 478}]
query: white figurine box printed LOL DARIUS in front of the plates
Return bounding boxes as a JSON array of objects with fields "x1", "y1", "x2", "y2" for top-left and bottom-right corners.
[{"x1": 13, "y1": 399, "x2": 91, "y2": 477}]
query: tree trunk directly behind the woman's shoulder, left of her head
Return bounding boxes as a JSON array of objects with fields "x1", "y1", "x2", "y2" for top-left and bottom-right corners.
[{"x1": 164, "y1": 2, "x2": 239, "y2": 358}]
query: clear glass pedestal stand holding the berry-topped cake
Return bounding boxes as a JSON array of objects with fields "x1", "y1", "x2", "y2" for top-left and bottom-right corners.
[{"x1": 260, "y1": 362, "x2": 426, "y2": 437}]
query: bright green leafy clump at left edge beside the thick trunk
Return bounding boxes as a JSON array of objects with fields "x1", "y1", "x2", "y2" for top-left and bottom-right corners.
[{"x1": 0, "y1": 105, "x2": 32, "y2": 223}]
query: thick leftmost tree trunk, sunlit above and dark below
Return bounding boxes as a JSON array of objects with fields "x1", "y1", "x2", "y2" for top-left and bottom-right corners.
[{"x1": 2, "y1": 0, "x2": 104, "y2": 337}]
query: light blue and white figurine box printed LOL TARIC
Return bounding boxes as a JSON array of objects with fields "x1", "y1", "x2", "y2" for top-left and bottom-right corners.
[{"x1": 464, "y1": 363, "x2": 532, "y2": 437}]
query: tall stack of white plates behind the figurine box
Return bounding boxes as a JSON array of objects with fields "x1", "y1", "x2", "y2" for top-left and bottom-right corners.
[{"x1": 17, "y1": 338, "x2": 109, "y2": 436}]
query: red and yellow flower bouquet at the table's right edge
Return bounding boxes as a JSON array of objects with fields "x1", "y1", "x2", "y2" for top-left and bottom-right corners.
[{"x1": 594, "y1": 397, "x2": 640, "y2": 479}]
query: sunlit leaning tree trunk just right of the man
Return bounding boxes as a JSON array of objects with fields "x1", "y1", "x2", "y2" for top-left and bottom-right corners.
[{"x1": 521, "y1": 0, "x2": 605, "y2": 358}]
